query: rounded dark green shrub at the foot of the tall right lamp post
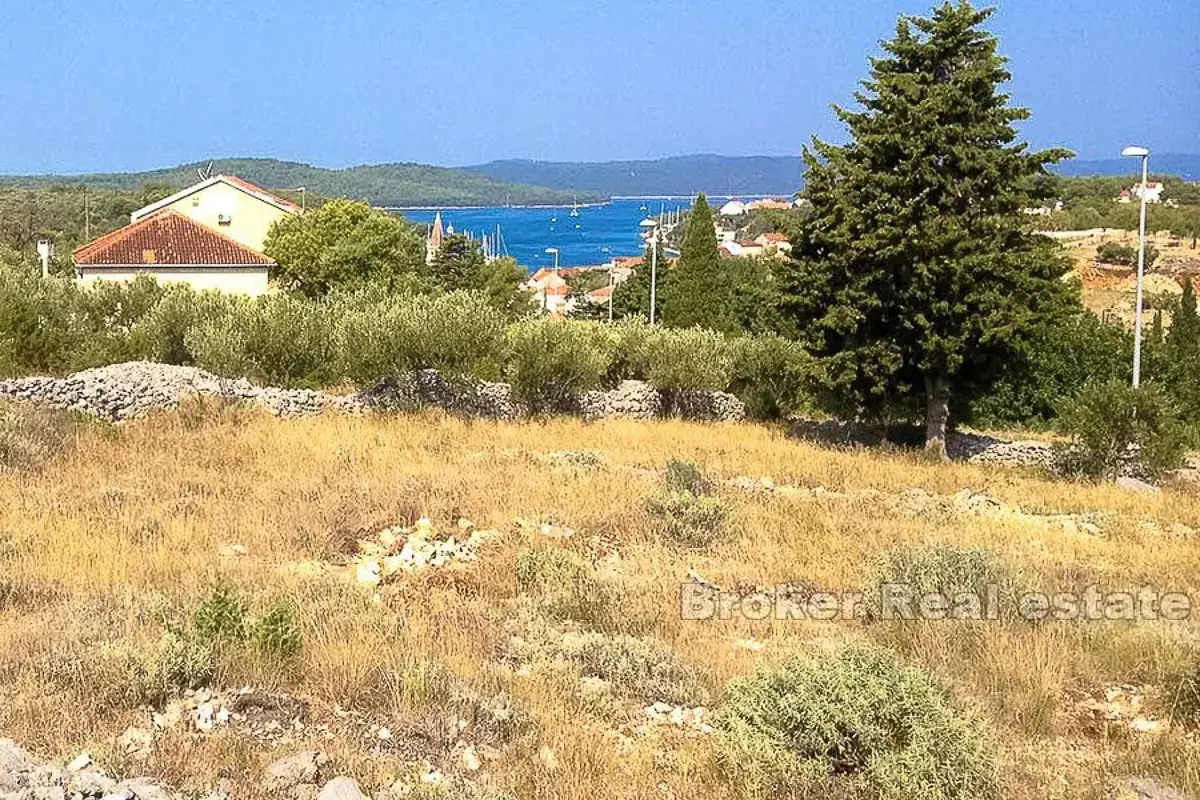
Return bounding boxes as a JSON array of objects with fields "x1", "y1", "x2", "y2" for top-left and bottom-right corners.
[{"x1": 1060, "y1": 380, "x2": 1193, "y2": 479}]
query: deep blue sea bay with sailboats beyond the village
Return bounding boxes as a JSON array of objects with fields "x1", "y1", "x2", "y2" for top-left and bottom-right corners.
[{"x1": 391, "y1": 198, "x2": 691, "y2": 272}]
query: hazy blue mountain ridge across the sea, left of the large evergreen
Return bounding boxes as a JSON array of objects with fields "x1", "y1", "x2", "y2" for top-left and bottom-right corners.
[{"x1": 463, "y1": 155, "x2": 804, "y2": 197}]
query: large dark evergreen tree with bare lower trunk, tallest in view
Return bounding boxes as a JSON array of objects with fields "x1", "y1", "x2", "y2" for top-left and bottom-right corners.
[{"x1": 782, "y1": 0, "x2": 1072, "y2": 456}]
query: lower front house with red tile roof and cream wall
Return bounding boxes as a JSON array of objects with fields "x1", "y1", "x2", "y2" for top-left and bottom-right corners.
[{"x1": 74, "y1": 207, "x2": 275, "y2": 296}]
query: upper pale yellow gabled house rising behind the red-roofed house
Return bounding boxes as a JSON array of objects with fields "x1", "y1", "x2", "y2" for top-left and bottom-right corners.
[{"x1": 130, "y1": 175, "x2": 300, "y2": 252}]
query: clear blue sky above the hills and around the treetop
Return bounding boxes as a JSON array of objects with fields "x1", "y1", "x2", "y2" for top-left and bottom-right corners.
[{"x1": 0, "y1": 0, "x2": 1200, "y2": 173}]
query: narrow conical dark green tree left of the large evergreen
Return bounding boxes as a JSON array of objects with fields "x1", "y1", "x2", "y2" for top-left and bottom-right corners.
[{"x1": 659, "y1": 194, "x2": 737, "y2": 332}]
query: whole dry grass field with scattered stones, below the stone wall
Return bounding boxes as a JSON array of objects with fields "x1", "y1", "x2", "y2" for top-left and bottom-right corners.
[{"x1": 0, "y1": 407, "x2": 1200, "y2": 800}]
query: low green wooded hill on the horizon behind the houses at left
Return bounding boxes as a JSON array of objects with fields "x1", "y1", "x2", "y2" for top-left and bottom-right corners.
[{"x1": 0, "y1": 158, "x2": 602, "y2": 206}]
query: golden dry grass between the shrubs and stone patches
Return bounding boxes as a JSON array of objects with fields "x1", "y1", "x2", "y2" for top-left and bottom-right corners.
[{"x1": 0, "y1": 411, "x2": 1200, "y2": 800}]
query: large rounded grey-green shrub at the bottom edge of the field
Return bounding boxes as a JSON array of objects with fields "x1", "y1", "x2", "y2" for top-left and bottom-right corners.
[{"x1": 716, "y1": 648, "x2": 998, "y2": 800}]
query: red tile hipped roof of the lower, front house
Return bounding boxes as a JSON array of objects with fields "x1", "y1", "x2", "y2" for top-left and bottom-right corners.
[{"x1": 74, "y1": 210, "x2": 275, "y2": 266}]
